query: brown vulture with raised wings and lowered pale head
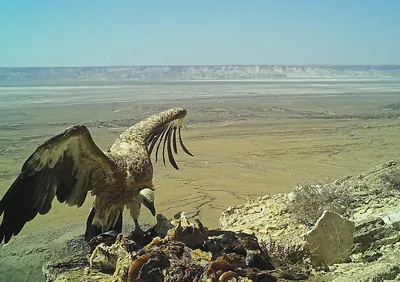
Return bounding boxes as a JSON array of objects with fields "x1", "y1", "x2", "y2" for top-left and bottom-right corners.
[{"x1": 0, "y1": 108, "x2": 193, "y2": 244}]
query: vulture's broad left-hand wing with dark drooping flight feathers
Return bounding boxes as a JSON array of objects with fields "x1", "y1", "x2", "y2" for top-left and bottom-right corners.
[{"x1": 0, "y1": 125, "x2": 116, "y2": 243}]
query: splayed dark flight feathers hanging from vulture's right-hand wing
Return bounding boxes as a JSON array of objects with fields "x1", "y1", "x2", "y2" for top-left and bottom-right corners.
[{"x1": 148, "y1": 119, "x2": 193, "y2": 169}]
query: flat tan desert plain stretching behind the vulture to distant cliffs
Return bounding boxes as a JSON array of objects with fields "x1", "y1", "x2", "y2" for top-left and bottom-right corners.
[{"x1": 0, "y1": 81, "x2": 400, "y2": 281}]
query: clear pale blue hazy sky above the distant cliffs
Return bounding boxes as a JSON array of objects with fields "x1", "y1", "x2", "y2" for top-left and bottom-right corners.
[{"x1": 0, "y1": 0, "x2": 400, "y2": 67}]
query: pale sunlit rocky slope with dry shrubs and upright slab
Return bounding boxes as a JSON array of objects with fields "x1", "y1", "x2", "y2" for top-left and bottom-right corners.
[{"x1": 220, "y1": 160, "x2": 400, "y2": 281}]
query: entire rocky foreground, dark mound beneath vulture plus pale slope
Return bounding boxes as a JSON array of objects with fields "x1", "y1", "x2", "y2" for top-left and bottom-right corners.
[{"x1": 39, "y1": 160, "x2": 400, "y2": 282}]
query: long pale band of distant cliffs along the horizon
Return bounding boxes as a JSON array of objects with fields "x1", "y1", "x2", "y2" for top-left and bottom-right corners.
[{"x1": 0, "y1": 65, "x2": 400, "y2": 85}]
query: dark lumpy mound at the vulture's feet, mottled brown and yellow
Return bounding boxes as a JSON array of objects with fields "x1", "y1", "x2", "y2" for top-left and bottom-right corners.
[{"x1": 43, "y1": 213, "x2": 284, "y2": 282}]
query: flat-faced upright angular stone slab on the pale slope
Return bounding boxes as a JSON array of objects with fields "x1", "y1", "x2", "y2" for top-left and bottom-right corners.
[{"x1": 306, "y1": 211, "x2": 354, "y2": 265}]
